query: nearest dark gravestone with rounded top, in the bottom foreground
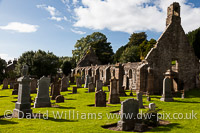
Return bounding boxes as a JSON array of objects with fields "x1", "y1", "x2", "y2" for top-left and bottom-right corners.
[{"x1": 118, "y1": 98, "x2": 139, "y2": 131}]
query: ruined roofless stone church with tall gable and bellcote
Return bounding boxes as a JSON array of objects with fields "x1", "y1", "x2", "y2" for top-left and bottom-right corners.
[{"x1": 72, "y1": 2, "x2": 200, "y2": 94}]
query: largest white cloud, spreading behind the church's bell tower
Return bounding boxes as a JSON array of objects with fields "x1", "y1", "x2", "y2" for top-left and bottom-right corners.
[{"x1": 74, "y1": 0, "x2": 200, "y2": 33}]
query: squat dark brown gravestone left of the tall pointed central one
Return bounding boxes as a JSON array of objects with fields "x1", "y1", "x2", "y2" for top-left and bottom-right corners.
[{"x1": 95, "y1": 90, "x2": 106, "y2": 107}]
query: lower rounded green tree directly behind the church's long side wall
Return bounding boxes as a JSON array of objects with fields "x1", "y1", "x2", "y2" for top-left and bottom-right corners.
[{"x1": 119, "y1": 46, "x2": 140, "y2": 63}]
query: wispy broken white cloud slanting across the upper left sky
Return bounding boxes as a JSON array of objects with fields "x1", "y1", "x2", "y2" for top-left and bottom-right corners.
[{"x1": 36, "y1": 4, "x2": 68, "y2": 22}]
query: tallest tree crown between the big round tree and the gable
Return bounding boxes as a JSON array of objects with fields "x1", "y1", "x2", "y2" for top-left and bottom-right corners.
[{"x1": 127, "y1": 32, "x2": 147, "y2": 46}]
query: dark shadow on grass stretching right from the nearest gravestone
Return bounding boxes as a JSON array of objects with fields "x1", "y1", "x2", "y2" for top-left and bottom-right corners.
[{"x1": 150, "y1": 123, "x2": 182, "y2": 132}]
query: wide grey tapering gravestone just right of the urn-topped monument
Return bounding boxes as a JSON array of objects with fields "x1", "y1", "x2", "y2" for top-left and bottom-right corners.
[{"x1": 34, "y1": 76, "x2": 51, "y2": 108}]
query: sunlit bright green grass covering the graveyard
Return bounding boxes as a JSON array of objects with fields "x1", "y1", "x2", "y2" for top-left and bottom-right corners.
[{"x1": 0, "y1": 86, "x2": 200, "y2": 133}]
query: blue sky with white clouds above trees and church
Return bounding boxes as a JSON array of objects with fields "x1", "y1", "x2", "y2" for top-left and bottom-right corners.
[{"x1": 0, "y1": 0, "x2": 200, "y2": 61}]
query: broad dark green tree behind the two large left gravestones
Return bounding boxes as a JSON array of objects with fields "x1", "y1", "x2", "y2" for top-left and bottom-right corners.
[{"x1": 16, "y1": 50, "x2": 59, "y2": 78}]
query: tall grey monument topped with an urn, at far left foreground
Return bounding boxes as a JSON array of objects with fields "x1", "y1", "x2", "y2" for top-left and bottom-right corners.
[{"x1": 12, "y1": 65, "x2": 32, "y2": 118}]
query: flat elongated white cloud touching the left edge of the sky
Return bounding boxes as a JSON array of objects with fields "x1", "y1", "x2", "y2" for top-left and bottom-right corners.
[{"x1": 0, "y1": 22, "x2": 39, "y2": 33}]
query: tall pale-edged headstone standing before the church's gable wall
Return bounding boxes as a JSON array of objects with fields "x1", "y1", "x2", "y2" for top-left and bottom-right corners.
[{"x1": 160, "y1": 70, "x2": 174, "y2": 102}]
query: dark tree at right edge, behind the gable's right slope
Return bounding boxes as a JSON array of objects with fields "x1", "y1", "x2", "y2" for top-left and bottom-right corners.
[{"x1": 187, "y1": 28, "x2": 200, "y2": 59}]
